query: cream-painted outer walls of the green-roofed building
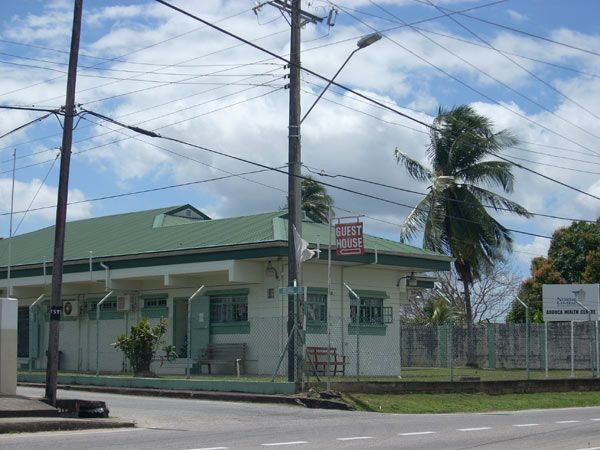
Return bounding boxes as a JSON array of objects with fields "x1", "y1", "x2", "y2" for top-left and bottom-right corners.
[{"x1": 21, "y1": 261, "x2": 422, "y2": 375}]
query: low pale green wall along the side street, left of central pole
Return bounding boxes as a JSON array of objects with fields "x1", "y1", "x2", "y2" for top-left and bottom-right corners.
[{"x1": 18, "y1": 373, "x2": 294, "y2": 394}]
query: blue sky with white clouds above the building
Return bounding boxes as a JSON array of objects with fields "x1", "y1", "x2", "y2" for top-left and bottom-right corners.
[{"x1": 0, "y1": 0, "x2": 600, "y2": 274}]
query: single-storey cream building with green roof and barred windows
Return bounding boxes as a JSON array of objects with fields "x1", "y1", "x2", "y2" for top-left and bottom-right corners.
[{"x1": 0, "y1": 205, "x2": 451, "y2": 375}]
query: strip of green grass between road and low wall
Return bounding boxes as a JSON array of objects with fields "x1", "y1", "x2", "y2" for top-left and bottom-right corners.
[{"x1": 343, "y1": 392, "x2": 600, "y2": 414}]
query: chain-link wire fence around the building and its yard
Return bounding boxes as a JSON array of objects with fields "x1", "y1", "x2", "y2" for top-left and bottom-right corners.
[{"x1": 24, "y1": 315, "x2": 600, "y2": 381}]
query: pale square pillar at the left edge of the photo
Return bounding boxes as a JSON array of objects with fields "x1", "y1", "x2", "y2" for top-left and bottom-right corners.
[{"x1": 0, "y1": 298, "x2": 17, "y2": 395}]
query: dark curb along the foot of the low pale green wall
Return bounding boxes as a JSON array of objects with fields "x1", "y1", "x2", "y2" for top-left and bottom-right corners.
[{"x1": 18, "y1": 382, "x2": 354, "y2": 411}]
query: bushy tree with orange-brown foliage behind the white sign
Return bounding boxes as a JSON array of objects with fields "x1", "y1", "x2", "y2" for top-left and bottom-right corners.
[{"x1": 506, "y1": 219, "x2": 600, "y2": 323}]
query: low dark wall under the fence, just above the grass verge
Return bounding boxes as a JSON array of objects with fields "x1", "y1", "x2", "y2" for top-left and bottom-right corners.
[{"x1": 331, "y1": 378, "x2": 600, "y2": 394}]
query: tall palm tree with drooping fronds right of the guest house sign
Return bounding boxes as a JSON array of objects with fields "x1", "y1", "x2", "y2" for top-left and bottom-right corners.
[{"x1": 395, "y1": 105, "x2": 531, "y2": 365}]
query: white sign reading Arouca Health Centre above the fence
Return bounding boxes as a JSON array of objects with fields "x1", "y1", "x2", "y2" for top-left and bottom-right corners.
[{"x1": 542, "y1": 284, "x2": 600, "y2": 322}]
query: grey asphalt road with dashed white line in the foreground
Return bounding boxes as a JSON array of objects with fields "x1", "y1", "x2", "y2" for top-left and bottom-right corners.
[{"x1": 0, "y1": 388, "x2": 600, "y2": 450}]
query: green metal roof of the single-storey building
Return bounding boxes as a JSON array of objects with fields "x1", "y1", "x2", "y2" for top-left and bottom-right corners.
[{"x1": 0, "y1": 205, "x2": 442, "y2": 267}]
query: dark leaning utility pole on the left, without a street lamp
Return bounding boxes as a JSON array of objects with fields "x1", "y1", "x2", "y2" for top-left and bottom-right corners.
[{"x1": 46, "y1": 0, "x2": 83, "y2": 406}]
